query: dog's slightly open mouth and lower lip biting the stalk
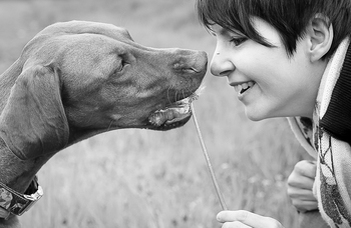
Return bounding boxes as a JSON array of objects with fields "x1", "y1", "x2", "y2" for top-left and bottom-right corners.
[{"x1": 149, "y1": 88, "x2": 202, "y2": 130}]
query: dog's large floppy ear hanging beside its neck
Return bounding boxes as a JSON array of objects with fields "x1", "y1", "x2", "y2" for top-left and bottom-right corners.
[{"x1": 0, "y1": 66, "x2": 69, "y2": 160}]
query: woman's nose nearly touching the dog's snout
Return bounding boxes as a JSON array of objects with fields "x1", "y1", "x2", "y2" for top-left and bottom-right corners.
[{"x1": 211, "y1": 51, "x2": 235, "y2": 76}]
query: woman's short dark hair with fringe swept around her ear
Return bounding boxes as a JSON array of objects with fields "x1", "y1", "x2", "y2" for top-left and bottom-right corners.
[{"x1": 196, "y1": 0, "x2": 351, "y2": 58}]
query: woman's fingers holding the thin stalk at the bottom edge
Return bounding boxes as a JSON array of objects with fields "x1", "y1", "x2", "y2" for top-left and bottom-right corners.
[{"x1": 217, "y1": 210, "x2": 283, "y2": 228}]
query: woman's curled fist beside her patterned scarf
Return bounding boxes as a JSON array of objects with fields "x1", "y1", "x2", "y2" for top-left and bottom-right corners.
[{"x1": 288, "y1": 160, "x2": 318, "y2": 212}]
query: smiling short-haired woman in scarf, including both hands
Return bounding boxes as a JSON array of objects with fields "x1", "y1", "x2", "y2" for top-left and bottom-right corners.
[{"x1": 197, "y1": 0, "x2": 351, "y2": 228}]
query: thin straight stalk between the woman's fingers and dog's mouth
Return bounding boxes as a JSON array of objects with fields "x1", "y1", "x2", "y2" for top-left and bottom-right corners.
[{"x1": 191, "y1": 103, "x2": 227, "y2": 210}]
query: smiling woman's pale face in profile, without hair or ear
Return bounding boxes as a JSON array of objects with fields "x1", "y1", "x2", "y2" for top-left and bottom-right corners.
[{"x1": 211, "y1": 18, "x2": 326, "y2": 120}]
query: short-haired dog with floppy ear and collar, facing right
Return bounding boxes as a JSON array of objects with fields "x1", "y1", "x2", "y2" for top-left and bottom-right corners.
[{"x1": 0, "y1": 21, "x2": 207, "y2": 227}]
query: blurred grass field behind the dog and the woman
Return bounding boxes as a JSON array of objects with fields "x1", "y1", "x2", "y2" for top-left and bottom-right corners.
[{"x1": 0, "y1": 0, "x2": 314, "y2": 228}]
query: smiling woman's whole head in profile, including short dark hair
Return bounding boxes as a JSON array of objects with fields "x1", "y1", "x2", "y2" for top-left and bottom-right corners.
[{"x1": 198, "y1": 0, "x2": 351, "y2": 120}]
